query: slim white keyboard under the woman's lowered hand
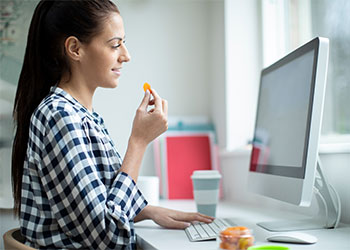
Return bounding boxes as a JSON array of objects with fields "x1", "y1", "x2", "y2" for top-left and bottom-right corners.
[{"x1": 185, "y1": 218, "x2": 236, "y2": 241}]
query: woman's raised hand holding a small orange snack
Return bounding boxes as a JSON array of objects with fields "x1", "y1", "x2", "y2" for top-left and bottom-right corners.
[{"x1": 130, "y1": 89, "x2": 168, "y2": 146}]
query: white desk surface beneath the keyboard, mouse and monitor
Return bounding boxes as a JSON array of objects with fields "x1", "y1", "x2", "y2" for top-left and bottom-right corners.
[{"x1": 135, "y1": 200, "x2": 350, "y2": 250}]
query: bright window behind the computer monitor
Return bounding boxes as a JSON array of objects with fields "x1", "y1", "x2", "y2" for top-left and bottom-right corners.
[{"x1": 261, "y1": 0, "x2": 350, "y2": 139}]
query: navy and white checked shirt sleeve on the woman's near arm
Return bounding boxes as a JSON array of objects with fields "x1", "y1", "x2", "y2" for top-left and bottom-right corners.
[{"x1": 38, "y1": 110, "x2": 147, "y2": 249}]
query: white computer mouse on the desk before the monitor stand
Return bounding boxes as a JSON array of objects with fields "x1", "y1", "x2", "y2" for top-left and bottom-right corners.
[{"x1": 266, "y1": 232, "x2": 317, "y2": 244}]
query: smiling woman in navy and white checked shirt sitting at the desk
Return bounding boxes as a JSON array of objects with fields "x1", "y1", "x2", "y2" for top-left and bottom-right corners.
[{"x1": 12, "y1": 0, "x2": 213, "y2": 249}]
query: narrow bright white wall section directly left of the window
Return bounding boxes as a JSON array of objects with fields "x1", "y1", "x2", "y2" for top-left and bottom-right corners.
[{"x1": 225, "y1": 0, "x2": 262, "y2": 150}]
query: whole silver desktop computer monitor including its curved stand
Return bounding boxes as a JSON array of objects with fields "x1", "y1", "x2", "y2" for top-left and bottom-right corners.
[{"x1": 247, "y1": 37, "x2": 340, "y2": 231}]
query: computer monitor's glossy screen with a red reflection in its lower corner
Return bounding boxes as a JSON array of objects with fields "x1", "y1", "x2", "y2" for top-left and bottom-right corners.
[{"x1": 251, "y1": 49, "x2": 315, "y2": 178}]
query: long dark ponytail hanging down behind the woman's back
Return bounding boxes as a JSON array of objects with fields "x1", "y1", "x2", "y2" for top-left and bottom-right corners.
[{"x1": 12, "y1": 1, "x2": 55, "y2": 217}]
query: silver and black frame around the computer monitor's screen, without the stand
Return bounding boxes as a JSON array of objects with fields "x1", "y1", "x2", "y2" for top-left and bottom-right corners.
[{"x1": 247, "y1": 37, "x2": 329, "y2": 206}]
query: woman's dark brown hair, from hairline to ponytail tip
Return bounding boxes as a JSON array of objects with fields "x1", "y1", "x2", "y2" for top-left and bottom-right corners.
[{"x1": 12, "y1": 0, "x2": 119, "y2": 215}]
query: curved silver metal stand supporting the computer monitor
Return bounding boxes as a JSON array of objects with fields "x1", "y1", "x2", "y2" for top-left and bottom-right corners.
[{"x1": 257, "y1": 157, "x2": 341, "y2": 232}]
